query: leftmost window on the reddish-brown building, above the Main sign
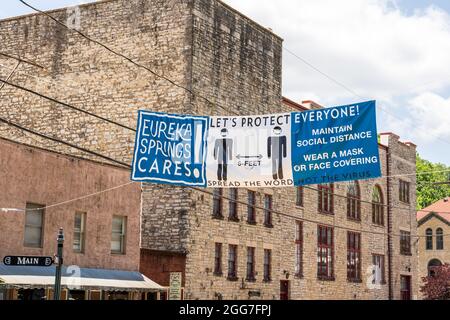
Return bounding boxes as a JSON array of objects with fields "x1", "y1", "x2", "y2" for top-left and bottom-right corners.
[{"x1": 23, "y1": 203, "x2": 45, "y2": 248}]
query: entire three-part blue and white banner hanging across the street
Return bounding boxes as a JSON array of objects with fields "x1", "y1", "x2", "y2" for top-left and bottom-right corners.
[{"x1": 131, "y1": 101, "x2": 381, "y2": 188}]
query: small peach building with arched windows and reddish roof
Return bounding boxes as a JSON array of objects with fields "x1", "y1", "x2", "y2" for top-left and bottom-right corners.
[{"x1": 417, "y1": 197, "x2": 450, "y2": 298}]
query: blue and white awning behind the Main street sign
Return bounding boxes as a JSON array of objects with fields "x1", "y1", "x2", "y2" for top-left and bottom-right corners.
[{"x1": 0, "y1": 264, "x2": 165, "y2": 292}]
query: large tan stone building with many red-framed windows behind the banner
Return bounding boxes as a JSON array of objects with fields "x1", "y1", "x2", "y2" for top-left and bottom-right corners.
[{"x1": 0, "y1": 0, "x2": 417, "y2": 299}]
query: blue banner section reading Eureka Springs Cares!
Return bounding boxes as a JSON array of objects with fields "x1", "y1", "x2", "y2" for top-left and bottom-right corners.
[{"x1": 131, "y1": 111, "x2": 209, "y2": 187}]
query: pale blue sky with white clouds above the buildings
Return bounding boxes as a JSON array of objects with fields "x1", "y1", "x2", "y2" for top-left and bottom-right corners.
[{"x1": 0, "y1": 0, "x2": 450, "y2": 165}]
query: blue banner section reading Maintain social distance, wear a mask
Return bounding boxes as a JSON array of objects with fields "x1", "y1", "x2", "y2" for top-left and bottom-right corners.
[{"x1": 291, "y1": 101, "x2": 381, "y2": 185}]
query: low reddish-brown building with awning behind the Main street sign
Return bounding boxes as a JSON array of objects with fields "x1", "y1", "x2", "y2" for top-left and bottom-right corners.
[{"x1": 0, "y1": 138, "x2": 163, "y2": 300}]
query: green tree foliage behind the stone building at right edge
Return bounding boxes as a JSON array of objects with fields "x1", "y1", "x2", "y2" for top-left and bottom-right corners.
[{"x1": 416, "y1": 154, "x2": 450, "y2": 209}]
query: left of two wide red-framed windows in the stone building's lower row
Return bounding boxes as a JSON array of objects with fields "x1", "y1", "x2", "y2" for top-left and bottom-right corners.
[{"x1": 317, "y1": 226, "x2": 334, "y2": 280}]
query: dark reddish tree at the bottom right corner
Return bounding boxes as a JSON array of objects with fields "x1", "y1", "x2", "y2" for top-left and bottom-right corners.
[{"x1": 420, "y1": 263, "x2": 450, "y2": 300}]
